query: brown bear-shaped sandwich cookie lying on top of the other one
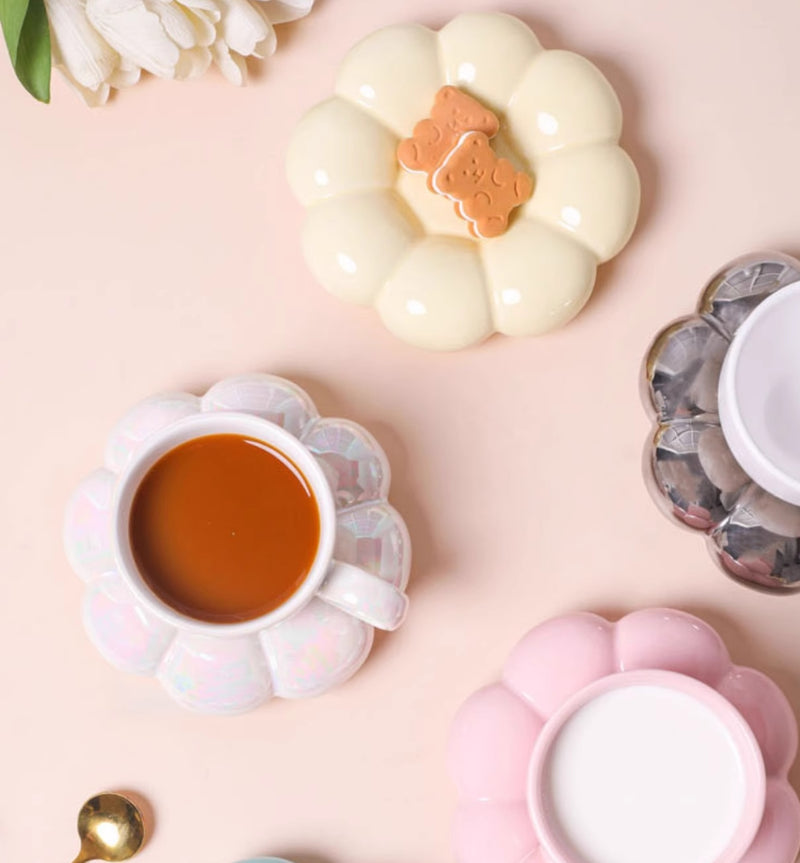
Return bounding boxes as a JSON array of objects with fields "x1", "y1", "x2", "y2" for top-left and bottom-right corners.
[{"x1": 432, "y1": 132, "x2": 533, "y2": 238}]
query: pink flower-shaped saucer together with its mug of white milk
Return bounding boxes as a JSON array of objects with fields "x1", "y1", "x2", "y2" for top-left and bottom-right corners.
[{"x1": 449, "y1": 609, "x2": 800, "y2": 863}]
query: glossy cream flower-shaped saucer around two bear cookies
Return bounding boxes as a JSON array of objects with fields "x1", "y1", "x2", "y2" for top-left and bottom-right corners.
[{"x1": 287, "y1": 13, "x2": 639, "y2": 350}]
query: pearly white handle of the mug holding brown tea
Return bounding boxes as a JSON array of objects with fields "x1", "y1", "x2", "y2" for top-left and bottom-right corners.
[{"x1": 317, "y1": 560, "x2": 408, "y2": 632}]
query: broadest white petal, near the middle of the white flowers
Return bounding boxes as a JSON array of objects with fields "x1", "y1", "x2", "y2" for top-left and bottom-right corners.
[{"x1": 86, "y1": 0, "x2": 180, "y2": 78}]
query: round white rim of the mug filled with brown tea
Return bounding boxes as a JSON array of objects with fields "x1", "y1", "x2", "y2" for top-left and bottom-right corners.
[{"x1": 112, "y1": 411, "x2": 336, "y2": 637}]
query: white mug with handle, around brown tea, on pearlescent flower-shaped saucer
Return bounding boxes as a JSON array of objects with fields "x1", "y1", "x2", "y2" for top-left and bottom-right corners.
[{"x1": 113, "y1": 411, "x2": 408, "y2": 636}]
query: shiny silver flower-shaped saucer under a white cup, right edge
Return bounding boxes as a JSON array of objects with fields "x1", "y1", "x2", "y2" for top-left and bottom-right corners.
[{"x1": 645, "y1": 253, "x2": 800, "y2": 591}]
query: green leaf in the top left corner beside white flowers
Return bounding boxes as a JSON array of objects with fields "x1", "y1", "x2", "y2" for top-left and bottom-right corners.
[{"x1": 0, "y1": 0, "x2": 51, "y2": 102}]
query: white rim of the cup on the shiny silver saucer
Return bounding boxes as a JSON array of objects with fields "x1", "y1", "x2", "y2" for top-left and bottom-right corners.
[{"x1": 717, "y1": 281, "x2": 800, "y2": 506}]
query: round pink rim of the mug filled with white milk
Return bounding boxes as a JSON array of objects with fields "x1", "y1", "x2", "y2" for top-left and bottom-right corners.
[{"x1": 527, "y1": 669, "x2": 767, "y2": 863}]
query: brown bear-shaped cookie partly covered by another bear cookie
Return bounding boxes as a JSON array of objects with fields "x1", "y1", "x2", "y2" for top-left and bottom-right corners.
[{"x1": 397, "y1": 86, "x2": 500, "y2": 188}]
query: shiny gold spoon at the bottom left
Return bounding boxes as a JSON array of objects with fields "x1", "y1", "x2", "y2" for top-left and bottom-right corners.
[{"x1": 72, "y1": 792, "x2": 144, "y2": 863}]
